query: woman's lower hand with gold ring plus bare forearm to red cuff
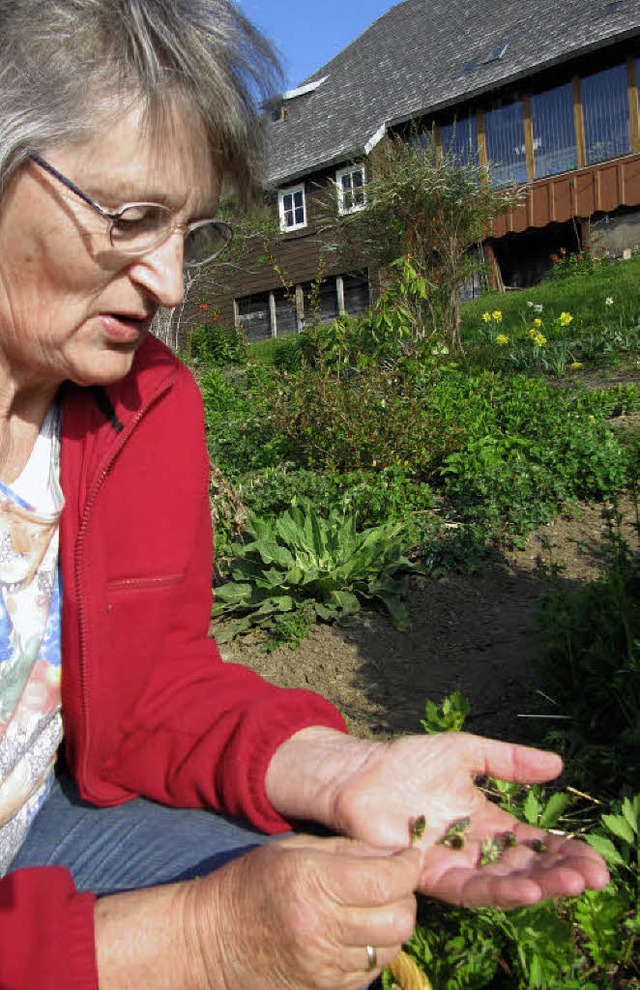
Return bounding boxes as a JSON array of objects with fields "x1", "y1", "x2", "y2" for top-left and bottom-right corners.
[{"x1": 96, "y1": 836, "x2": 421, "y2": 990}]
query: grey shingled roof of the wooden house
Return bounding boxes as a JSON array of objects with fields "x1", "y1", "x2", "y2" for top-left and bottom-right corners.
[{"x1": 267, "y1": 0, "x2": 640, "y2": 186}]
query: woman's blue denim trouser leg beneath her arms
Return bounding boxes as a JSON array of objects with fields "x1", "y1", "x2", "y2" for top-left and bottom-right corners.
[{"x1": 11, "y1": 774, "x2": 280, "y2": 895}]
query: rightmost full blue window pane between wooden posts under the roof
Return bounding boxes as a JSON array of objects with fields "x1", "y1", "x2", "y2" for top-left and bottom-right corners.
[{"x1": 582, "y1": 65, "x2": 631, "y2": 164}]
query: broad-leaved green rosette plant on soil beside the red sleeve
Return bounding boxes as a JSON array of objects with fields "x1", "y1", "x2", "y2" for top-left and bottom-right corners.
[{"x1": 213, "y1": 503, "x2": 417, "y2": 639}]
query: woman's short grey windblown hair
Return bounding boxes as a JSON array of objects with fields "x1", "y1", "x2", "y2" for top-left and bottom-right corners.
[{"x1": 0, "y1": 0, "x2": 280, "y2": 202}]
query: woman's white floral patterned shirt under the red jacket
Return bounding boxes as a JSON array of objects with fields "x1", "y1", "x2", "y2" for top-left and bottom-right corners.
[{"x1": 0, "y1": 406, "x2": 64, "y2": 876}]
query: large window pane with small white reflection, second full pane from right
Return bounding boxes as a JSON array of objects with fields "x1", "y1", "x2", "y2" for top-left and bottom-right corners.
[{"x1": 531, "y1": 83, "x2": 578, "y2": 179}]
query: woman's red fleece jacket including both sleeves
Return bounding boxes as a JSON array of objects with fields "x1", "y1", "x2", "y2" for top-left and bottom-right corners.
[{"x1": 0, "y1": 337, "x2": 344, "y2": 990}]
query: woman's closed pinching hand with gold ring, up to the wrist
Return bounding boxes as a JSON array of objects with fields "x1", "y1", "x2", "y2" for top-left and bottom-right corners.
[{"x1": 190, "y1": 836, "x2": 420, "y2": 990}]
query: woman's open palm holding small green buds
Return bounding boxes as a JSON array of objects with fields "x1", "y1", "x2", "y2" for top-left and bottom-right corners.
[{"x1": 266, "y1": 729, "x2": 608, "y2": 908}]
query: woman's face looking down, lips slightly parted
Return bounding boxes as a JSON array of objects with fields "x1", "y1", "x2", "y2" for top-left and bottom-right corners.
[{"x1": 0, "y1": 103, "x2": 220, "y2": 389}]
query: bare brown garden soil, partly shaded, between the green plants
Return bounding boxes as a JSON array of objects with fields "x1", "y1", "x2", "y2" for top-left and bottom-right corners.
[{"x1": 222, "y1": 505, "x2": 637, "y2": 742}]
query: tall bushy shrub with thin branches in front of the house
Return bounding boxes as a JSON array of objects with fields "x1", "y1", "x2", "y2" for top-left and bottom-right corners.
[{"x1": 326, "y1": 135, "x2": 523, "y2": 348}]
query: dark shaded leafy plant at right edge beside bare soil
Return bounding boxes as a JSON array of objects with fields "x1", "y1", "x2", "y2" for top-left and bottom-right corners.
[{"x1": 540, "y1": 510, "x2": 640, "y2": 794}]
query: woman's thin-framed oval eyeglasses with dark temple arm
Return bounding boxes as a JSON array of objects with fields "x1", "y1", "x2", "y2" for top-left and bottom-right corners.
[{"x1": 29, "y1": 151, "x2": 233, "y2": 268}]
